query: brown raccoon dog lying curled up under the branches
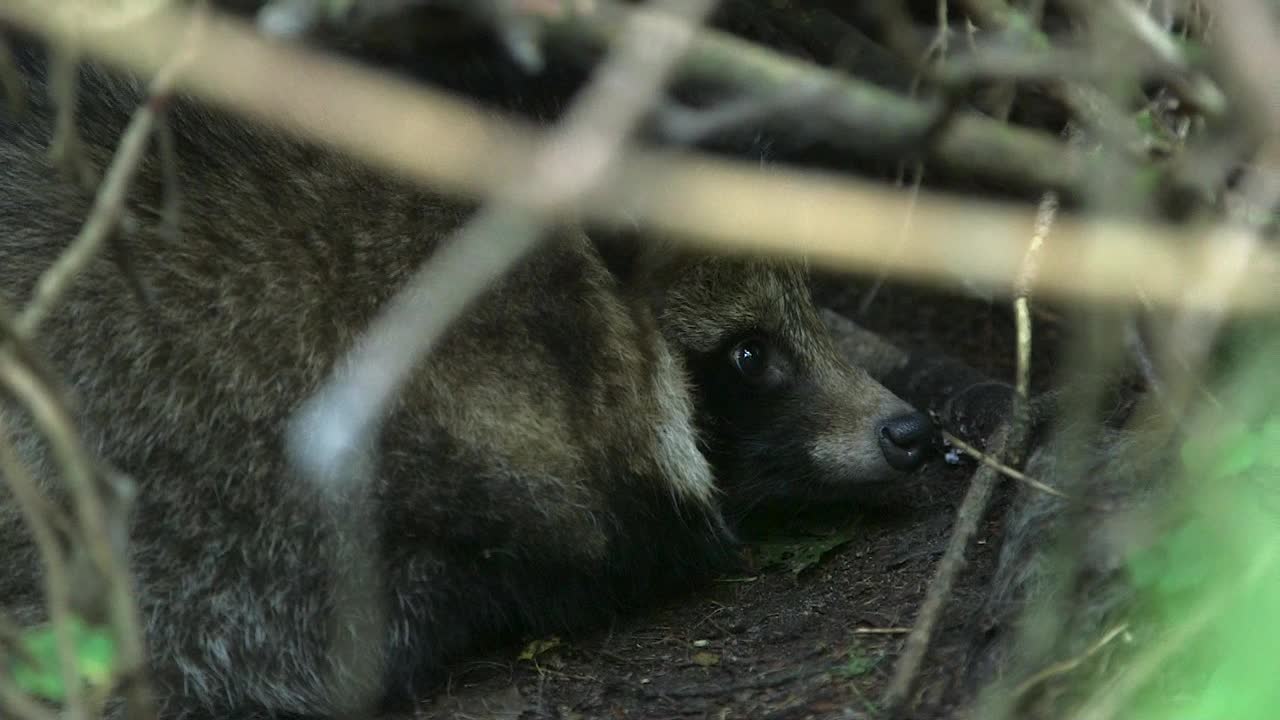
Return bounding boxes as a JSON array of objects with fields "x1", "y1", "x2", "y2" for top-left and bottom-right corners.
[{"x1": 0, "y1": 47, "x2": 927, "y2": 716}]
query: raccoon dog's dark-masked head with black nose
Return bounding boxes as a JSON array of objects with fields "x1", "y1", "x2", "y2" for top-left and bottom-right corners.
[{"x1": 634, "y1": 244, "x2": 933, "y2": 518}]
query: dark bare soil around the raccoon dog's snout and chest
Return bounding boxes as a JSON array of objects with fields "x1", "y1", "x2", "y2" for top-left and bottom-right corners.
[{"x1": 404, "y1": 279, "x2": 1056, "y2": 720}]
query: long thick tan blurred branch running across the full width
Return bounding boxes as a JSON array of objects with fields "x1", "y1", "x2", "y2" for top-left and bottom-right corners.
[{"x1": 0, "y1": 0, "x2": 1280, "y2": 311}]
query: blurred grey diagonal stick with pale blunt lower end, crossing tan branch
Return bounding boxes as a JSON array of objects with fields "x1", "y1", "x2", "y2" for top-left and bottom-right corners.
[{"x1": 289, "y1": 0, "x2": 727, "y2": 482}]
